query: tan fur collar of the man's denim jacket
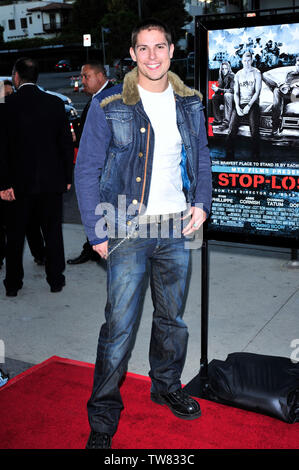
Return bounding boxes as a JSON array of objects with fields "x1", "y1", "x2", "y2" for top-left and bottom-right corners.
[{"x1": 101, "y1": 67, "x2": 202, "y2": 107}]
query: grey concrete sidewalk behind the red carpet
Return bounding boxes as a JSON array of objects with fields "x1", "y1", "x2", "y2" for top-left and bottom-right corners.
[{"x1": 0, "y1": 224, "x2": 299, "y2": 383}]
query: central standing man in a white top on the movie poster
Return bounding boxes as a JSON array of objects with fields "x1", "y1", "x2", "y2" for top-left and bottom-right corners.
[{"x1": 226, "y1": 51, "x2": 262, "y2": 161}]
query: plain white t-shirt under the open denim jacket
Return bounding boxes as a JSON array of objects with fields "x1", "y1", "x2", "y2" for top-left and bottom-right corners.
[{"x1": 138, "y1": 84, "x2": 186, "y2": 215}]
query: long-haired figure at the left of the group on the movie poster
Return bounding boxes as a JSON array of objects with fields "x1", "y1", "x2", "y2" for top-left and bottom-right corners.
[{"x1": 211, "y1": 61, "x2": 235, "y2": 131}]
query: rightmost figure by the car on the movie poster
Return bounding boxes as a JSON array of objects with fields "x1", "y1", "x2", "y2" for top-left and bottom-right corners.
[{"x1": 263, "y1": 55, "x2": 299, "y2": 137}]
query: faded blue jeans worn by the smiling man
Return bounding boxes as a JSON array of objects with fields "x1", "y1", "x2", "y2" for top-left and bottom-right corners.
[{"x1": 87, "y1": 223, "x2": 190, "y2": 435}]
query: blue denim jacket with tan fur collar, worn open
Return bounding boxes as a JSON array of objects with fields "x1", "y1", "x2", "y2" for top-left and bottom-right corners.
[{"x1": 75, "y1": 69, "x2": 212, "y2": 245}]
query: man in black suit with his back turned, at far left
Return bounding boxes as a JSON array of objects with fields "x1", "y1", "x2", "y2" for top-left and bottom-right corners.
[{"x1": 0, "y1": 58, "x2": 73, "y2": 296}]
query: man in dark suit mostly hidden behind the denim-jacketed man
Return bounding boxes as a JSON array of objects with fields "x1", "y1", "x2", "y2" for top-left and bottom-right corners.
[{"x1": 67, "y1": 61, "x2": 113, "y2": 264}]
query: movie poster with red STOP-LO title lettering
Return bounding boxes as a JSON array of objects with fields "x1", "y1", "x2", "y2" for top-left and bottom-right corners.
[{"x1": 207, "y1": 23, "x2": 299, "y2": 247}]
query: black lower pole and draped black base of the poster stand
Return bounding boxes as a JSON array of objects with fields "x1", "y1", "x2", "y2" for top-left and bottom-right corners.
[{"x1": 184, "y1": 239, "x2": 299, "y2": 424}]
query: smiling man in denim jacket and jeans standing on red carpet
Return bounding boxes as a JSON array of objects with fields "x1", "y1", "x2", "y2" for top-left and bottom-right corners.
[{"x1": 75, "y1": 19, "x2": 211, "y2": 449}]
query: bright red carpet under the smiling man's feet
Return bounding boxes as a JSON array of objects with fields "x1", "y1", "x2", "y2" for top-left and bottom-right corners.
[{"x1": 0, "y1": 356, "x2": 299, "y2": 449}]
